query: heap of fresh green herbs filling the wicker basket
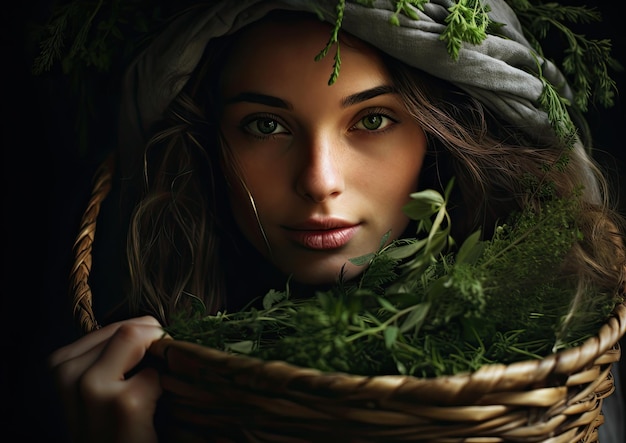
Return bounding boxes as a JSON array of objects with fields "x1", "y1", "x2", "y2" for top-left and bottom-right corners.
[{"x1": 166, "y1": 183, "x2": 619, "y2": 377}]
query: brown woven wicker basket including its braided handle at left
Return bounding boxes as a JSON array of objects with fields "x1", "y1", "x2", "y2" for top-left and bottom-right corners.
[{"x1": 71, "y1": 155, "x2": 626, "y2": 443}]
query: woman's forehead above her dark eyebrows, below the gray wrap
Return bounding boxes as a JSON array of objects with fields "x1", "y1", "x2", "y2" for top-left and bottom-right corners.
[{"x1": 222, "y1": 15, "x2": 386, "y2": 93}]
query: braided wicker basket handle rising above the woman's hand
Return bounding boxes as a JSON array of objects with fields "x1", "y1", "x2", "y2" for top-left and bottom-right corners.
[{"x1": 70, "y1": 154, "x2": 114, "y2": 334}]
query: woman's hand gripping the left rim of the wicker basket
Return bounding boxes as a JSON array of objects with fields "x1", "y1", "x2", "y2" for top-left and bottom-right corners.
[{"x1": 49, "y1": 317, "x2": 165, "y2": 443}]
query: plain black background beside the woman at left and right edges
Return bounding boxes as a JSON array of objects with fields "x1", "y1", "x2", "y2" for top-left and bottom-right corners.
[{"x1": 0, "y1": 0, "x2": 626, "y2": 442}]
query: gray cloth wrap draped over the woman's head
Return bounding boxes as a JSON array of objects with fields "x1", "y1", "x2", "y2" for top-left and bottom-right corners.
[{"x1": 120, "y1": 0, "x2": 572, "y2": 177}]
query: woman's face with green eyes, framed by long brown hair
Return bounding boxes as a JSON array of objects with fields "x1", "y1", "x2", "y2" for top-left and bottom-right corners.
[{"x1": 220, "y1": 19, "x2": 426, "y2": 284}]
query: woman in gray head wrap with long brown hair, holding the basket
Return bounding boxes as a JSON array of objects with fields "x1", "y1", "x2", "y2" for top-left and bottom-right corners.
[{"x1": 51, "y1": 1, "x2": 625, "y2": 442}]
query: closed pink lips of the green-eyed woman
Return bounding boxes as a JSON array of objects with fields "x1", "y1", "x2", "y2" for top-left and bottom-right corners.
[{"x1": 285, "y1": 219, "x2": 360, "y2": 250}]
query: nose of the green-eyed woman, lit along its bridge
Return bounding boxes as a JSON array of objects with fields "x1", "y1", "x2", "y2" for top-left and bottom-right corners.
[{"x1": 296, "y1": 136, "x2": 346, "y2": 203}]
